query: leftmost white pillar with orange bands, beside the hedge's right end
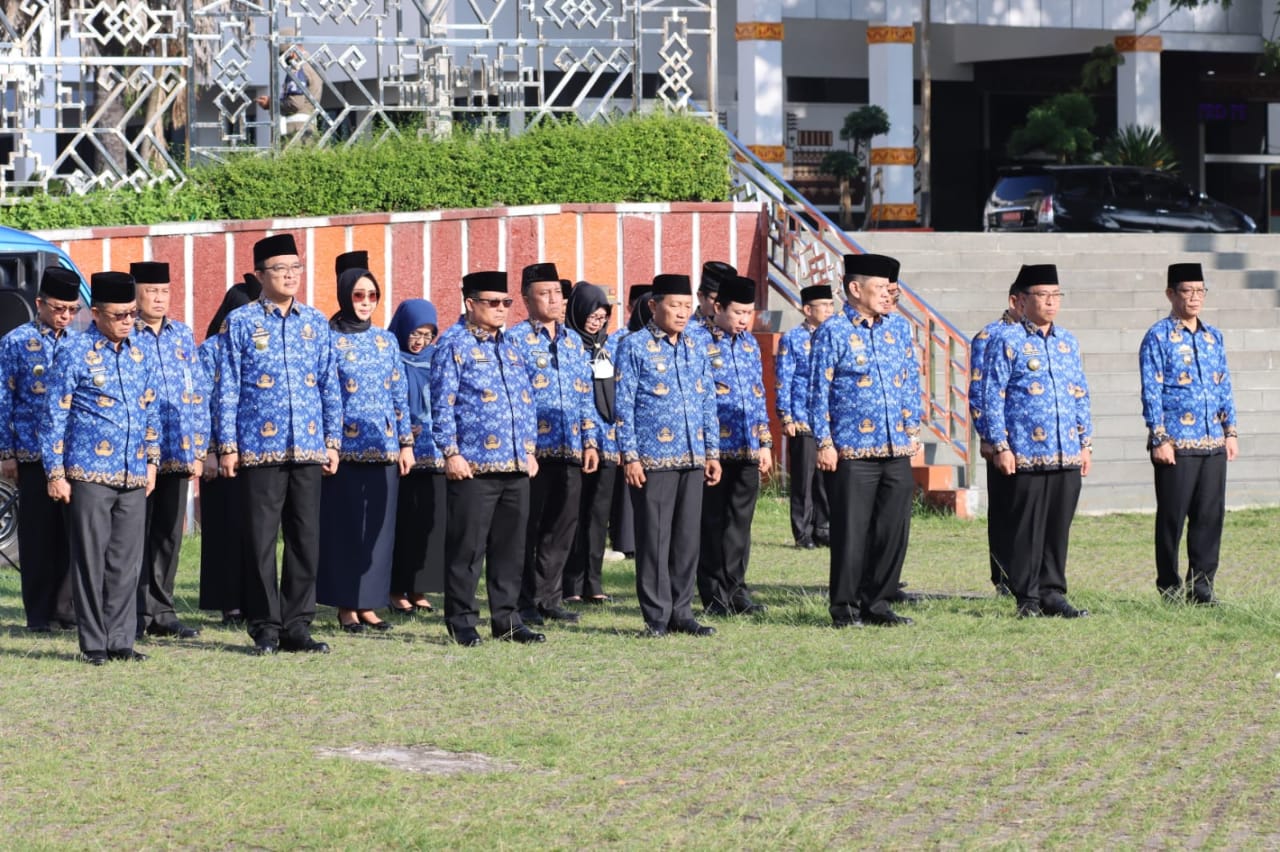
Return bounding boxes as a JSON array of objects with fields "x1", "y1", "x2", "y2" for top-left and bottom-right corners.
[{"x1": 733, "y1": 0, "x2": 787, "y2": 171}]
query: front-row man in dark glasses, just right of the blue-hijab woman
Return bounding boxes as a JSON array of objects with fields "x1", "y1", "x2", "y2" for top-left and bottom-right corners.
[{"x1": 431, "y1": 271, "x2": 547, "y2": 647}]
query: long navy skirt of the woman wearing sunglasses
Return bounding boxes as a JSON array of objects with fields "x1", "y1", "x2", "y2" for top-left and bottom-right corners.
[{"x1": 316, "y1": 462, "x2": 399, "y2": 609}]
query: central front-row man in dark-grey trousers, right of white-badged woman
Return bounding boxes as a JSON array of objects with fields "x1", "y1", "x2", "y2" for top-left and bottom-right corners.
[{"x1": 616, "y1": 275, "x2": 721, "y2": 637}]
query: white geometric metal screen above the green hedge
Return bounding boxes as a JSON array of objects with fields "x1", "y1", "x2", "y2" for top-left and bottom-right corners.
[{"x1": 0, "y1": 0, "x2": 716, "y2": 198}]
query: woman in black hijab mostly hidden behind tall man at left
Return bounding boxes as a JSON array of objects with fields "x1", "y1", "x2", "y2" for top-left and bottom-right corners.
[{"x1": 196, "y1": 274, "x2": 262, "y2": 627}]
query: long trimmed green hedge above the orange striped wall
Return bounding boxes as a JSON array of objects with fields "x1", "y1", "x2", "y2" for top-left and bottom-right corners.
[{"x1": 0, "y1": 115, "x2": 728, "y2": 230}]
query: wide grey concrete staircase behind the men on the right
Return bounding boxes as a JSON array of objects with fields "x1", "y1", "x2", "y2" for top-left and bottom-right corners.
[{"x1": 852, "y1": 232, "x2": 1280, "y2": 512}]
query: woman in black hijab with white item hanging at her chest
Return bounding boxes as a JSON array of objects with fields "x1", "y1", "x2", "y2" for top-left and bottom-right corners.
[{"x1": 563, "y1": 281, "x2": 618, "y2": 604}]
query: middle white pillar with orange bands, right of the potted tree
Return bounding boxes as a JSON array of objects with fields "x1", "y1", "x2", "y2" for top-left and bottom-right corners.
[{"x1": 867, "y1": 14, "x2": 920, "y2": 225}]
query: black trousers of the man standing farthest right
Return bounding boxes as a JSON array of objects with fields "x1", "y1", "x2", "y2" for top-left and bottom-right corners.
[{"x1": 1155, "y1": 453, "x2": 1226, "y2": 600}]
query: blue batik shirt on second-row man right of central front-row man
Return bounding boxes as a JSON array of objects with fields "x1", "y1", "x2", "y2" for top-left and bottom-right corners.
[{"x1": 699, "y1": 325, "x2": 773, "y2": 462}]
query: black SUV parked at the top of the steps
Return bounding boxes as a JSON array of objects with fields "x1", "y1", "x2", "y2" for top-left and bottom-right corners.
[{"x1": 982, "y1": 165, "x2": 1258, "y2": 234}]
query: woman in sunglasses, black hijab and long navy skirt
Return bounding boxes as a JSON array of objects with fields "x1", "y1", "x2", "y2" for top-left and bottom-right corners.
[{"x1": 316, "y1": 269, "x2": 413, "y2": 633}]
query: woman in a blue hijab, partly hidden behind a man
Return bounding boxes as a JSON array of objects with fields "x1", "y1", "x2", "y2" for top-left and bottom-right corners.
[{"x1": 387, "y1": 299, "x2": 445, "y2": 615}]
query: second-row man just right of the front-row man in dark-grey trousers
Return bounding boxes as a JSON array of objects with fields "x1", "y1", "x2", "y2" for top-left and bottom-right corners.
[{"x1": 698, "y1": 278, "x2": 773, "y2": 615}]
